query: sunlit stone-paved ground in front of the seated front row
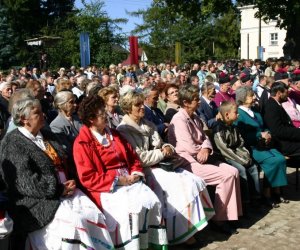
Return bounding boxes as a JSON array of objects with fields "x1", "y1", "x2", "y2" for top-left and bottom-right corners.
[{"x1": 171, "y1": 168, "x2": 300, "y2": 250}]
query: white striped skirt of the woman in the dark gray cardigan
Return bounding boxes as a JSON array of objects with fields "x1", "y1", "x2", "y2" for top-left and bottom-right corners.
[{"x1": 26, "y1": 189, "x2": 114, "y2": 250}]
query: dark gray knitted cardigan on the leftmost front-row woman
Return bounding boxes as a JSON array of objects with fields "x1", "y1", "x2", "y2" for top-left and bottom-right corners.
[{"x1": 0, "y1": 129, "x2": 64, "y2": 233}]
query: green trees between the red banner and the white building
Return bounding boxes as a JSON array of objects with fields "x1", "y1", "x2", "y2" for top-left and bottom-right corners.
[{"x1": 131, "y1": 0, "x2": 240, "y2": 62}]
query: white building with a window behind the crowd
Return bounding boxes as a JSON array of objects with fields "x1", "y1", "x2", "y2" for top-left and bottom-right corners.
[{"x1": 239, "y1": 5, "x2": 286, "y2": 60}]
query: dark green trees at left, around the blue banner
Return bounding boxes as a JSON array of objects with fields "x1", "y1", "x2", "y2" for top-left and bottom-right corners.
[{"x1": 0, "y1": 0, "x2": 127, "y2": 68}]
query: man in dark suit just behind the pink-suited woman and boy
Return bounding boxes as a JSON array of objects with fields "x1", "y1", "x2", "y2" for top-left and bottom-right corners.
[{"x1": 197, "y1": 82, "x2": 219, "y2": 128}]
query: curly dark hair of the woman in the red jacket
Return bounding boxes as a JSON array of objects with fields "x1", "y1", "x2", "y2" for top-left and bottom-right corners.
[{"x1": 78, "y1": 95, "x2": 105, "y2": 127}]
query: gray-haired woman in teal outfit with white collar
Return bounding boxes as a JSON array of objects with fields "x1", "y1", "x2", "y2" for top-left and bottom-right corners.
[{"x1": 236, "y1": 86, "x2": 288, "y2": 208}]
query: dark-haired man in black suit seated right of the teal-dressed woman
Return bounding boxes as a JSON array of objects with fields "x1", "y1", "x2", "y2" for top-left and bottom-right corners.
[{"x1": 264, "y1": 82, "x2": 300, "y2": 156}]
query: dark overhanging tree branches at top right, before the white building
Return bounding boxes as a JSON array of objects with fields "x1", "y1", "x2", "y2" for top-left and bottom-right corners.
[{"x1": 155, "y1": 0, "x2": 300, "y2": 58}]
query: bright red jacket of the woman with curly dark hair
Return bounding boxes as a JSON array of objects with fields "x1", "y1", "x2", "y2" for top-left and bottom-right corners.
[{"x1": 73, "y1": 125, "x2": 143, "y2": 208}]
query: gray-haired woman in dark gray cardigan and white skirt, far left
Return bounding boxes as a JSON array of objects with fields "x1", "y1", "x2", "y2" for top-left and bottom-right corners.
[{"x1": 0, "y1": 98, "x2": 113, "y2": 250}]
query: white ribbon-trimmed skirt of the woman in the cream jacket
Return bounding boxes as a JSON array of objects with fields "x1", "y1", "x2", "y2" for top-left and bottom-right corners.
[{"x1": 146, "y1": 168, "x2": 215, "y2": 245}]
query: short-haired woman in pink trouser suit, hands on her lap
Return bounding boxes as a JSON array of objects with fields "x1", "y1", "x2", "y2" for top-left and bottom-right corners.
[{"x1": 168, "y1": 86, "x2": 242, "y2": 234}]
